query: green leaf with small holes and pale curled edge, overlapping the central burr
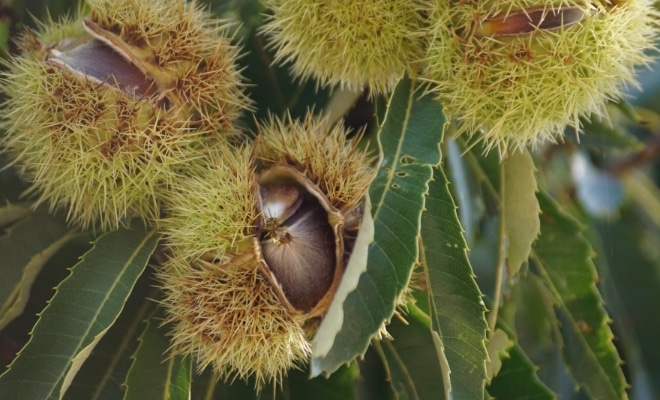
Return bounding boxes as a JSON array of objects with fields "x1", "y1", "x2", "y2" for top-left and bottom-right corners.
[{"x1": 311, "y1": 78, "x2": 444, "y2": 376}]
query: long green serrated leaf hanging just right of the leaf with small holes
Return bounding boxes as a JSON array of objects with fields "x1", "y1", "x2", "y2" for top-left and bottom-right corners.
[{"x1": 422, "y1": 169, "x2": 488, "y2": 399}]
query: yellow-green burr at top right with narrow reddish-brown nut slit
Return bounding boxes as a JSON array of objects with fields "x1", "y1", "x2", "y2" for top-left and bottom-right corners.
[{"x1": 426, "y1": 0, "x2": 658, "y2": 157}]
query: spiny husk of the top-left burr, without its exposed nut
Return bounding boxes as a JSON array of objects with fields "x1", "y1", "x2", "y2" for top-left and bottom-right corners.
[{"x1": 0, "y1": 0, "x2": 249, "y2": 229}]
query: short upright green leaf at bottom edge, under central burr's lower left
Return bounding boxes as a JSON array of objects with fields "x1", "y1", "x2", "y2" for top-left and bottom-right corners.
[{"x1": 124, "y1": 308, "x2": 192, "y2": 400}]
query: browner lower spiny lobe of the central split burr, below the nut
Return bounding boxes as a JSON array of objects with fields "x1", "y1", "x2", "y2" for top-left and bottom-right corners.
[{"x1": 160, "y1": 252, "x2": 311, "y2": 388}]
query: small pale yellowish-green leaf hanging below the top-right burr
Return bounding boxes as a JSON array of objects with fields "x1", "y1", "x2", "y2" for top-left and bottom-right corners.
[{"x1": 501, "y1": 150, "x2": 540, "y2": 276}]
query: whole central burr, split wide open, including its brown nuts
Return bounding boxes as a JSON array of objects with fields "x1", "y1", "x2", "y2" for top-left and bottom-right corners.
[{"x1": 158, "y1": 116, "x2": 375, "y2": 388}]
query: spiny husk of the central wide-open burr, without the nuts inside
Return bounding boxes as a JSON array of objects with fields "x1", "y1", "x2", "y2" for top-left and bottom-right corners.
[{"x1": 158, "y1": 113, "x2": 374, "y2": 387}]
